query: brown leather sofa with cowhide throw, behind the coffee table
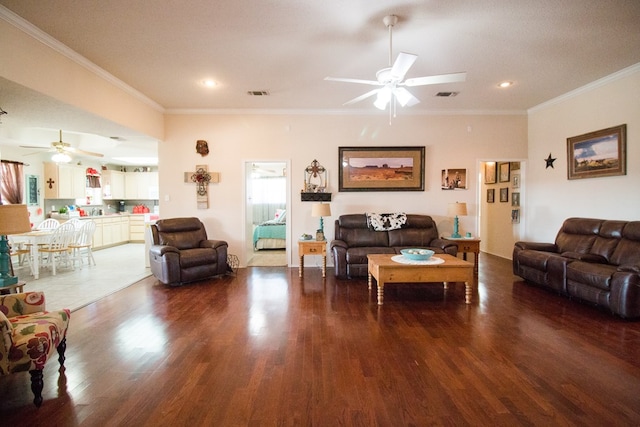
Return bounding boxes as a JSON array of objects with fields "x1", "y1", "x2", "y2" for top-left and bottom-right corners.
[{"x1": 331, "y1": 214, "x2": 458, "y2": 279}]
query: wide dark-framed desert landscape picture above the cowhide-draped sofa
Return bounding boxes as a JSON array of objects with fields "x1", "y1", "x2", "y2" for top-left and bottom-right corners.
[{"x1": 338, "y1": 146, "x2": 425, "y2": 191}]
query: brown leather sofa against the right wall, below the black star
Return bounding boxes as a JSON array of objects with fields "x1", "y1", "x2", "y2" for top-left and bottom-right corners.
[{"x1": 513, "y1": 218, "x2": 640, "y2": 319}]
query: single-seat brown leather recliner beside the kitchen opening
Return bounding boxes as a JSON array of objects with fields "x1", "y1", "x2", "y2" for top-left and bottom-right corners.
[{"x1": 149, "y1": 218, "x2": 228, "y2": 286}]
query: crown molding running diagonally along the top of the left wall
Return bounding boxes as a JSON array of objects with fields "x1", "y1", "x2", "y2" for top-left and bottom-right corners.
[{"x1": 0, "y1": 5, "x2": 164, "y2": 112}]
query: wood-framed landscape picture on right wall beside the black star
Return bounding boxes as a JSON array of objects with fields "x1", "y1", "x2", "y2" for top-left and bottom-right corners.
[{"x1": 567, "y1": 124, "x2": 627, "y2": 180}]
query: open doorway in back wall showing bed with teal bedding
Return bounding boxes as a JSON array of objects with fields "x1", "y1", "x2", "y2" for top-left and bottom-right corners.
[{"x1": 245, "y1": 160, "x2": 290, "y2": 267}]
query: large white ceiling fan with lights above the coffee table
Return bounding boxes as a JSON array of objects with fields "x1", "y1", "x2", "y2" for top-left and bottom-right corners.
[{"x1": 324, "y1": 15, "x2": 467, "y2": 116}]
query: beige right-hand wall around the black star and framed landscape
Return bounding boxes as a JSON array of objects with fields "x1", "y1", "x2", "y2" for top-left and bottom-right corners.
[{"x1": 524, "y1": 64, "x2": 640, "y2": 242}]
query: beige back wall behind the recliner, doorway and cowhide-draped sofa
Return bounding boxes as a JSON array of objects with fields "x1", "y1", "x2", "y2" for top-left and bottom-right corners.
[{"x1": 159, "y1": 112, "x2": 527, "y2": 265}]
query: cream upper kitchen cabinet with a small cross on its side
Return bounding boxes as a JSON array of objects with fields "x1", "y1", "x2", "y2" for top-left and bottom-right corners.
[{"x1": 44, "y1": 162, "x2": 87, "y2": 199}]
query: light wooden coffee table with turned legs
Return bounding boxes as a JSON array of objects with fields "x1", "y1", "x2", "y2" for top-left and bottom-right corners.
[{"x1": 367, "y1": 254, "x2": 474, "y2": 305}]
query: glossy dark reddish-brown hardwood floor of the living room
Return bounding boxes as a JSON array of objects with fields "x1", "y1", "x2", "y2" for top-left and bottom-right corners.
[{"x1": 0, "y1": 254, "x2": 640, "y2": 426}]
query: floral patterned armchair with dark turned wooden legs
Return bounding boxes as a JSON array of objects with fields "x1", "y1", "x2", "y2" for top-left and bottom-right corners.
[{"x1": 0, "y1": 292, "x2": 70, "y2": 407}]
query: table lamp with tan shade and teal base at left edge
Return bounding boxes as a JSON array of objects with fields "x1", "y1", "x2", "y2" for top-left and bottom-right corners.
[{"x1": 0, "y1": 205, "x2": 31, "y2": 287}]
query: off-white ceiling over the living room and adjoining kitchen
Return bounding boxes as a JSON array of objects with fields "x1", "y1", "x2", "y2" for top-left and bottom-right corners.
[{"x1": 0, "y1": 0, "x2": 640, "y2": 164}]
